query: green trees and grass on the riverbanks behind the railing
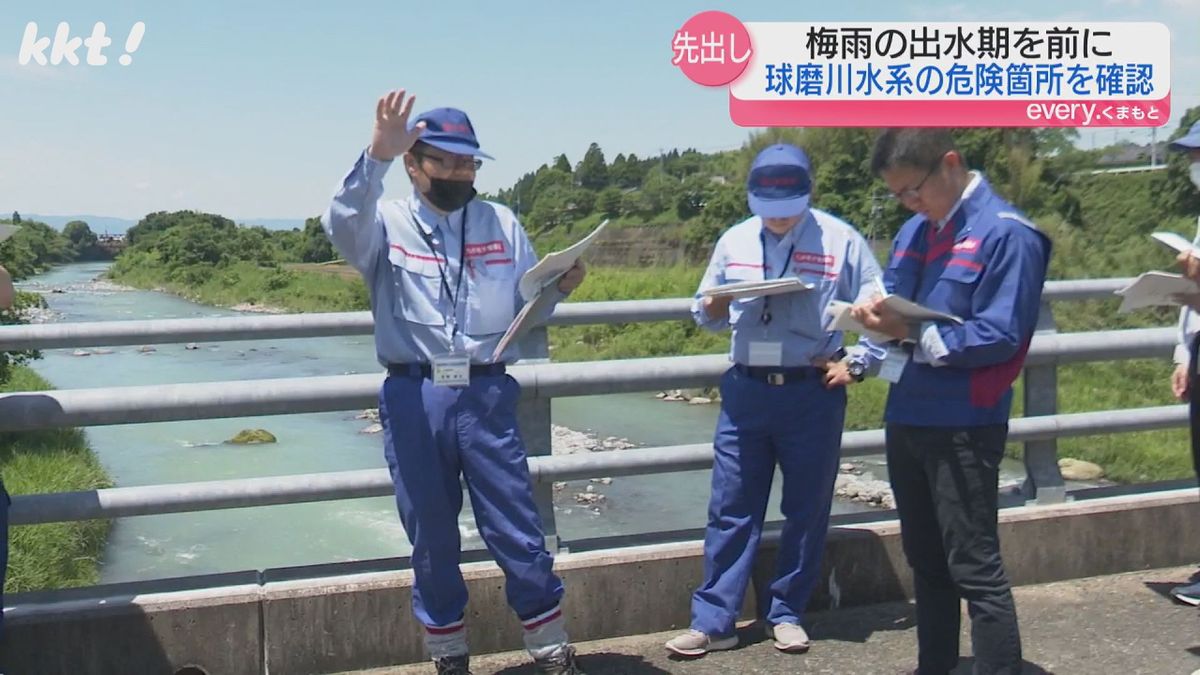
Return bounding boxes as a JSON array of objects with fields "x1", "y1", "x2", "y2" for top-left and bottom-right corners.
[{"x1": 0, "y1": 117, "x2": 1200, "y2": 590}]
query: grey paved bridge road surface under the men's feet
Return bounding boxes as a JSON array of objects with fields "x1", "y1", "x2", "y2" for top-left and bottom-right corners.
[{"x1": 359, "y1": 564, "x2": 1200, "y2": 675}]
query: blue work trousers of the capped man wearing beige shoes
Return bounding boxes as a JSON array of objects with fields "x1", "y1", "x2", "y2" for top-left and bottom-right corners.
[{"x1": 691, "y1": 366, "x2": 846, "y2": 637}]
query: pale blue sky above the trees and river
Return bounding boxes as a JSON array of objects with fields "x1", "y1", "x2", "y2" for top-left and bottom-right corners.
[{"x1": 0, "y1": 0, "x2": 1200, "y2": 220}]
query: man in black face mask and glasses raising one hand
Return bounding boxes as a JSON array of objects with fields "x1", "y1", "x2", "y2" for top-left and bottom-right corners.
[{"x1": 322, "y1": 90, "x2": 584, "y2": 675}]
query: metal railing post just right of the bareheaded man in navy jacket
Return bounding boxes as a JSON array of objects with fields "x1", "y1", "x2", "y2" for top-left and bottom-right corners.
[{"x1": 1021, "y1": 300, "x2": 1067, "y2": 504}]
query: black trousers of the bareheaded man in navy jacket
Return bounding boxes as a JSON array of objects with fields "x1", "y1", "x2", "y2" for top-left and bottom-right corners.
[{"x1": 887, "y1": 424, "x2": 1021, "y2": 675}]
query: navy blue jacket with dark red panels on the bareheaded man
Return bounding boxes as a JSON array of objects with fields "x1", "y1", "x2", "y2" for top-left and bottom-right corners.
[{"x1": 883, "y1": 177, "x2": 1051, "y2": 426}]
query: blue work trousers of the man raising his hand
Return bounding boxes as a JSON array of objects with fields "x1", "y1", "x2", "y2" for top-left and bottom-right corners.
[{"x1": 379, "y1": 375, "x2": 563, "y2": 627}]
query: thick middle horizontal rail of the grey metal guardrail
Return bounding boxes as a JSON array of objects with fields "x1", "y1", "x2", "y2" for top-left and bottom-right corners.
[{"x1": 0, "y1": 328, "x2": 1175, "y2": 431}]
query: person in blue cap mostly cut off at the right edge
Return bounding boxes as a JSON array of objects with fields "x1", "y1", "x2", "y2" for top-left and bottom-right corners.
[{"x1": 1169, "y1": 121, "x2": 1200, "y2": 605}]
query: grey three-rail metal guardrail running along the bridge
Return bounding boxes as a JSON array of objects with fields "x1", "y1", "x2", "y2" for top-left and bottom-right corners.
[{"x1": 0, "y1": 273, "x2": 1187, "y2": 539}]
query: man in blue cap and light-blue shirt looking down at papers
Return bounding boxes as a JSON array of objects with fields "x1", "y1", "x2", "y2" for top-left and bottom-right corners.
[{"x1": 666, "y1": 144, "x2": 881, "y2": 657}]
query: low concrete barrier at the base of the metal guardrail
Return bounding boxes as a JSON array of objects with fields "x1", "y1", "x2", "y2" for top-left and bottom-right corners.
[{"x1": 4, "y1": 489, "x2": 1200, "y2": 675}]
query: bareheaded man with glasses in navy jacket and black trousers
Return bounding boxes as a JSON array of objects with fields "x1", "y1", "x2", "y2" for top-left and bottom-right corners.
[{"x1": 851, "y1": 129, "x2": 1050, "y2": 675}]
